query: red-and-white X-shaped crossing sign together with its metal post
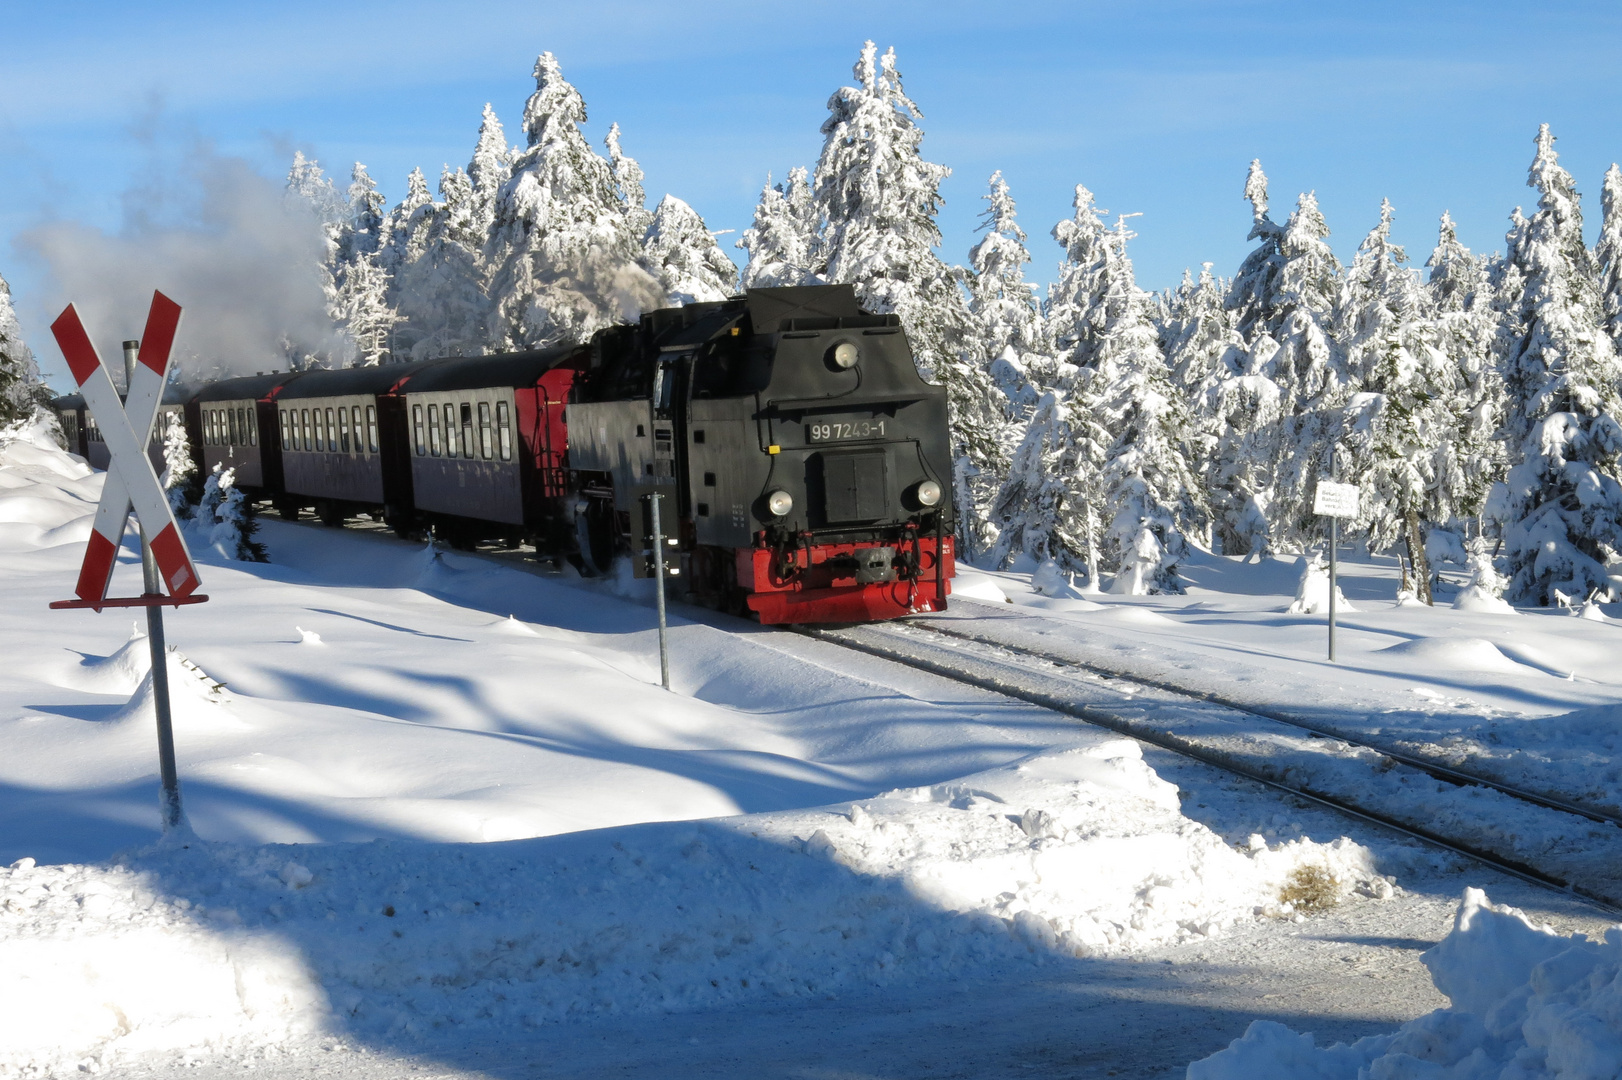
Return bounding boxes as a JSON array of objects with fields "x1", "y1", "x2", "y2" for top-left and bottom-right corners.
[{"x1": 50, "y1": 292, "x2": 208, "y2": 834}]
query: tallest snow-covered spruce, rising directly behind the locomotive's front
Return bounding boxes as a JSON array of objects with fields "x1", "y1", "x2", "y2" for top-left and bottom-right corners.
[{"x1": 813, "y1": 41, "x2": 1006, "y2": 555}]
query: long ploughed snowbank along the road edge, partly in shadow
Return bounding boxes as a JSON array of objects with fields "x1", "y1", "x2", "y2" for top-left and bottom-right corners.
[{"x1": 0, "y1": 739, "x2": 1390, "y2": 1074}]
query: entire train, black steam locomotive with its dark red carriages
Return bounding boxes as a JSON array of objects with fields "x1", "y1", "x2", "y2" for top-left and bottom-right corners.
[{"x1": 57, "y1": 285, "x2": 954, "y2": 624}]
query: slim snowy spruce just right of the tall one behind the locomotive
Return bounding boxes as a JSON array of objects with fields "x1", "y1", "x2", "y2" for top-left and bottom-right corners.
[{"x1": 968, "y1": 172, "x2": 1053, "y2": 430}]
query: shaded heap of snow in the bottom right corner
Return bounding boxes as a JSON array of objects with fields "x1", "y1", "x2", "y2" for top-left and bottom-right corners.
[{"x1": 1187, "y1": 889, "x2": 1622, "y2": 1080}]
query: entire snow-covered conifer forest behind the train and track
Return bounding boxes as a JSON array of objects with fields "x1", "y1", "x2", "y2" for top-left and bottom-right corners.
[{"x1": 9, "y1": 42, "x2": 1622, "y2": 605}]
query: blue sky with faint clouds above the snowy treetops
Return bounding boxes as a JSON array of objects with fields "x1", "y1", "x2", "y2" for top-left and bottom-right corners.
[{"x1": 0, "y1": 0, "x2": 1622, "y2": 382}]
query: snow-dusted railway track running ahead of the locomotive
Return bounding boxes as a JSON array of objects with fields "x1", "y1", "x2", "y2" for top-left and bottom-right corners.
[{"x1": 798, "y1": 612, "x2": 1622, "y2": 913}]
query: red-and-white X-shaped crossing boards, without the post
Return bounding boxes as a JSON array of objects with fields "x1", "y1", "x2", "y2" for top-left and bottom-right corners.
[{"x1": 50, "y1": 292, "x2": 201, "y2": 610}]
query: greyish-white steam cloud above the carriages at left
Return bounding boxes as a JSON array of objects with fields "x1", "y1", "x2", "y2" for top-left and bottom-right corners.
[{"x1": 18, "y1": 146, "x2": 333, "y2": 379}]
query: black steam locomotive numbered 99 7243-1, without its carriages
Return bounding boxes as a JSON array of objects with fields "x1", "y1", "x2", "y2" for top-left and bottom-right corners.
[{"x1": 568, "y1": 285, "x2": 952, "y2": 623}]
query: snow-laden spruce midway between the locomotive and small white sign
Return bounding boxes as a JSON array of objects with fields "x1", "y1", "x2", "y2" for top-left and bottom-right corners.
[{"x1": 1072, "y1": 219, "x2": 1210, "y2": 595}]
